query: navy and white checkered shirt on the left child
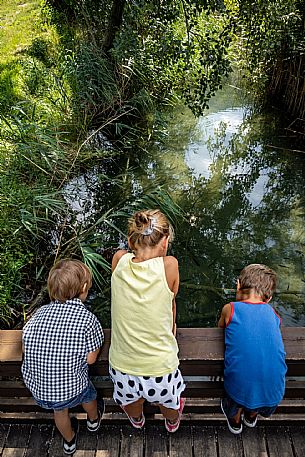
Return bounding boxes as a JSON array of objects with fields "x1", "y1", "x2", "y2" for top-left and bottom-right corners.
[{"x1": 22, "y1": 298, "x2": 104, "y2": 401}]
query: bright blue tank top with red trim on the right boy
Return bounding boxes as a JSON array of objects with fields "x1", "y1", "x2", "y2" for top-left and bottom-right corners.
[{"x1": 224, "y1": 302, "x2": 287, "y2": 410}]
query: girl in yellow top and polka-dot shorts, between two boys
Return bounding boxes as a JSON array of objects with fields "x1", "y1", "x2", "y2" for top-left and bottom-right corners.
[{"x1": 109, "y1": 210, "x2": 185, "y2": 432}]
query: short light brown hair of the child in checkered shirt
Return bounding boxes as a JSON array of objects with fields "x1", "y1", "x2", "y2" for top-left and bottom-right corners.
[{"x1": 48, "y1": 259, "x2": 92, "y2": 302}]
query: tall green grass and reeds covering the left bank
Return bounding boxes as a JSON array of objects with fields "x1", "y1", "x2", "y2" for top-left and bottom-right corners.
[{"x1": 0, "y1": 0, "x2": 180, "y2": 327}]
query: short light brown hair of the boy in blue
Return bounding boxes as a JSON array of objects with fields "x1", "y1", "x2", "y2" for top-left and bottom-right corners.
[{"x1": 238, "y1": 263, "x2": 276, "y2": 300}]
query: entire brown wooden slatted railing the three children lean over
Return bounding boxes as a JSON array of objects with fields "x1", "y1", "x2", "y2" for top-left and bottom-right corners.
[{"x1": 0, "y1": 327, "x2": 305, "y2": 419}]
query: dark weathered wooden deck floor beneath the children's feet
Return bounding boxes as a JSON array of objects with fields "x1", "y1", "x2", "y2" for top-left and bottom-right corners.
[{"x1": 0, "y1": 421, "x2": 305, "y2": 457}]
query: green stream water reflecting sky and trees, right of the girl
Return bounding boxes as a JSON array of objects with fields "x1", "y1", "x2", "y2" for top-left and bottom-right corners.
[{"x1": 131, "y1": 86, "x2": 305, "y2": 327}]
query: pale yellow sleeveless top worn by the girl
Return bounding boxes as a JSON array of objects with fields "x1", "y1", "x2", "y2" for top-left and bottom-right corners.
[{"x1": 109, "y1": 253, "x2": 179, "y2": 377}]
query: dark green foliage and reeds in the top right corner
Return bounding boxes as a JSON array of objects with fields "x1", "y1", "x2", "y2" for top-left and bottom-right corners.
[{"x1": 238, "y1": 0, "x2": 305, "y2": 117}]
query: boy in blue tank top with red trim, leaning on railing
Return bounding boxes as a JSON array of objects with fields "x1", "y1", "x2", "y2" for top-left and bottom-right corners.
[{"x1": 218, "y1": 264, "x2": 287, "y2": 434}]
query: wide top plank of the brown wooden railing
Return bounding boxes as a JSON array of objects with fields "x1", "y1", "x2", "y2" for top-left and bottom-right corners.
[{"x1": 0, "y1": 327, "x2": 305, "y2": 376}]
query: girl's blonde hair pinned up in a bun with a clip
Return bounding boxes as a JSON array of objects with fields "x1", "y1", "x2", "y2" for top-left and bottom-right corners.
[{"x1": 128, "y1": 209, "x2": 174, "y2": 251}]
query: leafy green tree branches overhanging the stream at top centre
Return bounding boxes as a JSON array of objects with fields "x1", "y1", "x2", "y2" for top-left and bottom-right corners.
[{"x1": 45, "y1": 0, "x2": 234, "y2": 115}]
